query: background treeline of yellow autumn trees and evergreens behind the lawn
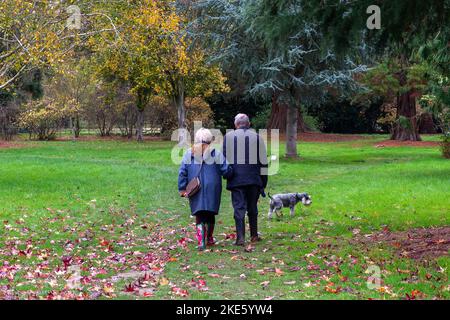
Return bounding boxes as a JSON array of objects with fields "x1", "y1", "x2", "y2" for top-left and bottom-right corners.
[{"x1": 0, "y1": 0, "x2": 450, "y2": 156}]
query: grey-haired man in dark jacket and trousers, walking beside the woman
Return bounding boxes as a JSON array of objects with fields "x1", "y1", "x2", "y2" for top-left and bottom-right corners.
[{"x1": 223, "y1": 113, "x2": 267, "y2": 246}]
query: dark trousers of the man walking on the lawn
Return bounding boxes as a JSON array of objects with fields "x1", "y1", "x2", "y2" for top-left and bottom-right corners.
[{"x1": 231, "y1": 185, "x2": 261, "y2": 242}]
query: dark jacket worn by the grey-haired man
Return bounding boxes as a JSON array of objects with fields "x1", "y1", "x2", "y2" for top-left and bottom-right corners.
[{"x1": 223, "y1": 129, "x2": 267, "y2": 190}]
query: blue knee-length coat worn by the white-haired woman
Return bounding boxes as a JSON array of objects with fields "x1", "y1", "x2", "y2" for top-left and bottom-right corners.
[{"x1": 178, "y1": 149, "x2": 233, "y2": 215}]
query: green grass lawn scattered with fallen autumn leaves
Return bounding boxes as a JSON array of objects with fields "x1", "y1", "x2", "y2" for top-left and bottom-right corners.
[{"x1": 0, "y1": 136, "x2": 450, "y2": 299}]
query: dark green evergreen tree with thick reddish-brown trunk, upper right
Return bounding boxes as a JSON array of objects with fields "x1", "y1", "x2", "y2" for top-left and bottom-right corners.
[{"x1": 304, "y1": 0, "x2": 450, "y2": 140}]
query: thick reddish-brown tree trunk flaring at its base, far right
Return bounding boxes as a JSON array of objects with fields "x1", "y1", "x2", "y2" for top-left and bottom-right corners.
[{"x1": 391, "y1": 91, "x2": 422, "y2": 141}]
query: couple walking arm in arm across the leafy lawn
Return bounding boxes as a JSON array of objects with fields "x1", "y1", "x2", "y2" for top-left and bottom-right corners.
[{"x1": 178, "y1": 114, "x2": 267, "y2": 250}]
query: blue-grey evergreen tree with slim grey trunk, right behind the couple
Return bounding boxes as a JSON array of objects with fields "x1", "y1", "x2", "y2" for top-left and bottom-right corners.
[{"x1": 195, "y1": 0, "x2": 364, "y2": 157}]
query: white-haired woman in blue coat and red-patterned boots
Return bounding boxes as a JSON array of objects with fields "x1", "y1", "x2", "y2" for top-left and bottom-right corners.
[{"x1": 178, "y1": 128, "x2": 232, "y2": 251}]
